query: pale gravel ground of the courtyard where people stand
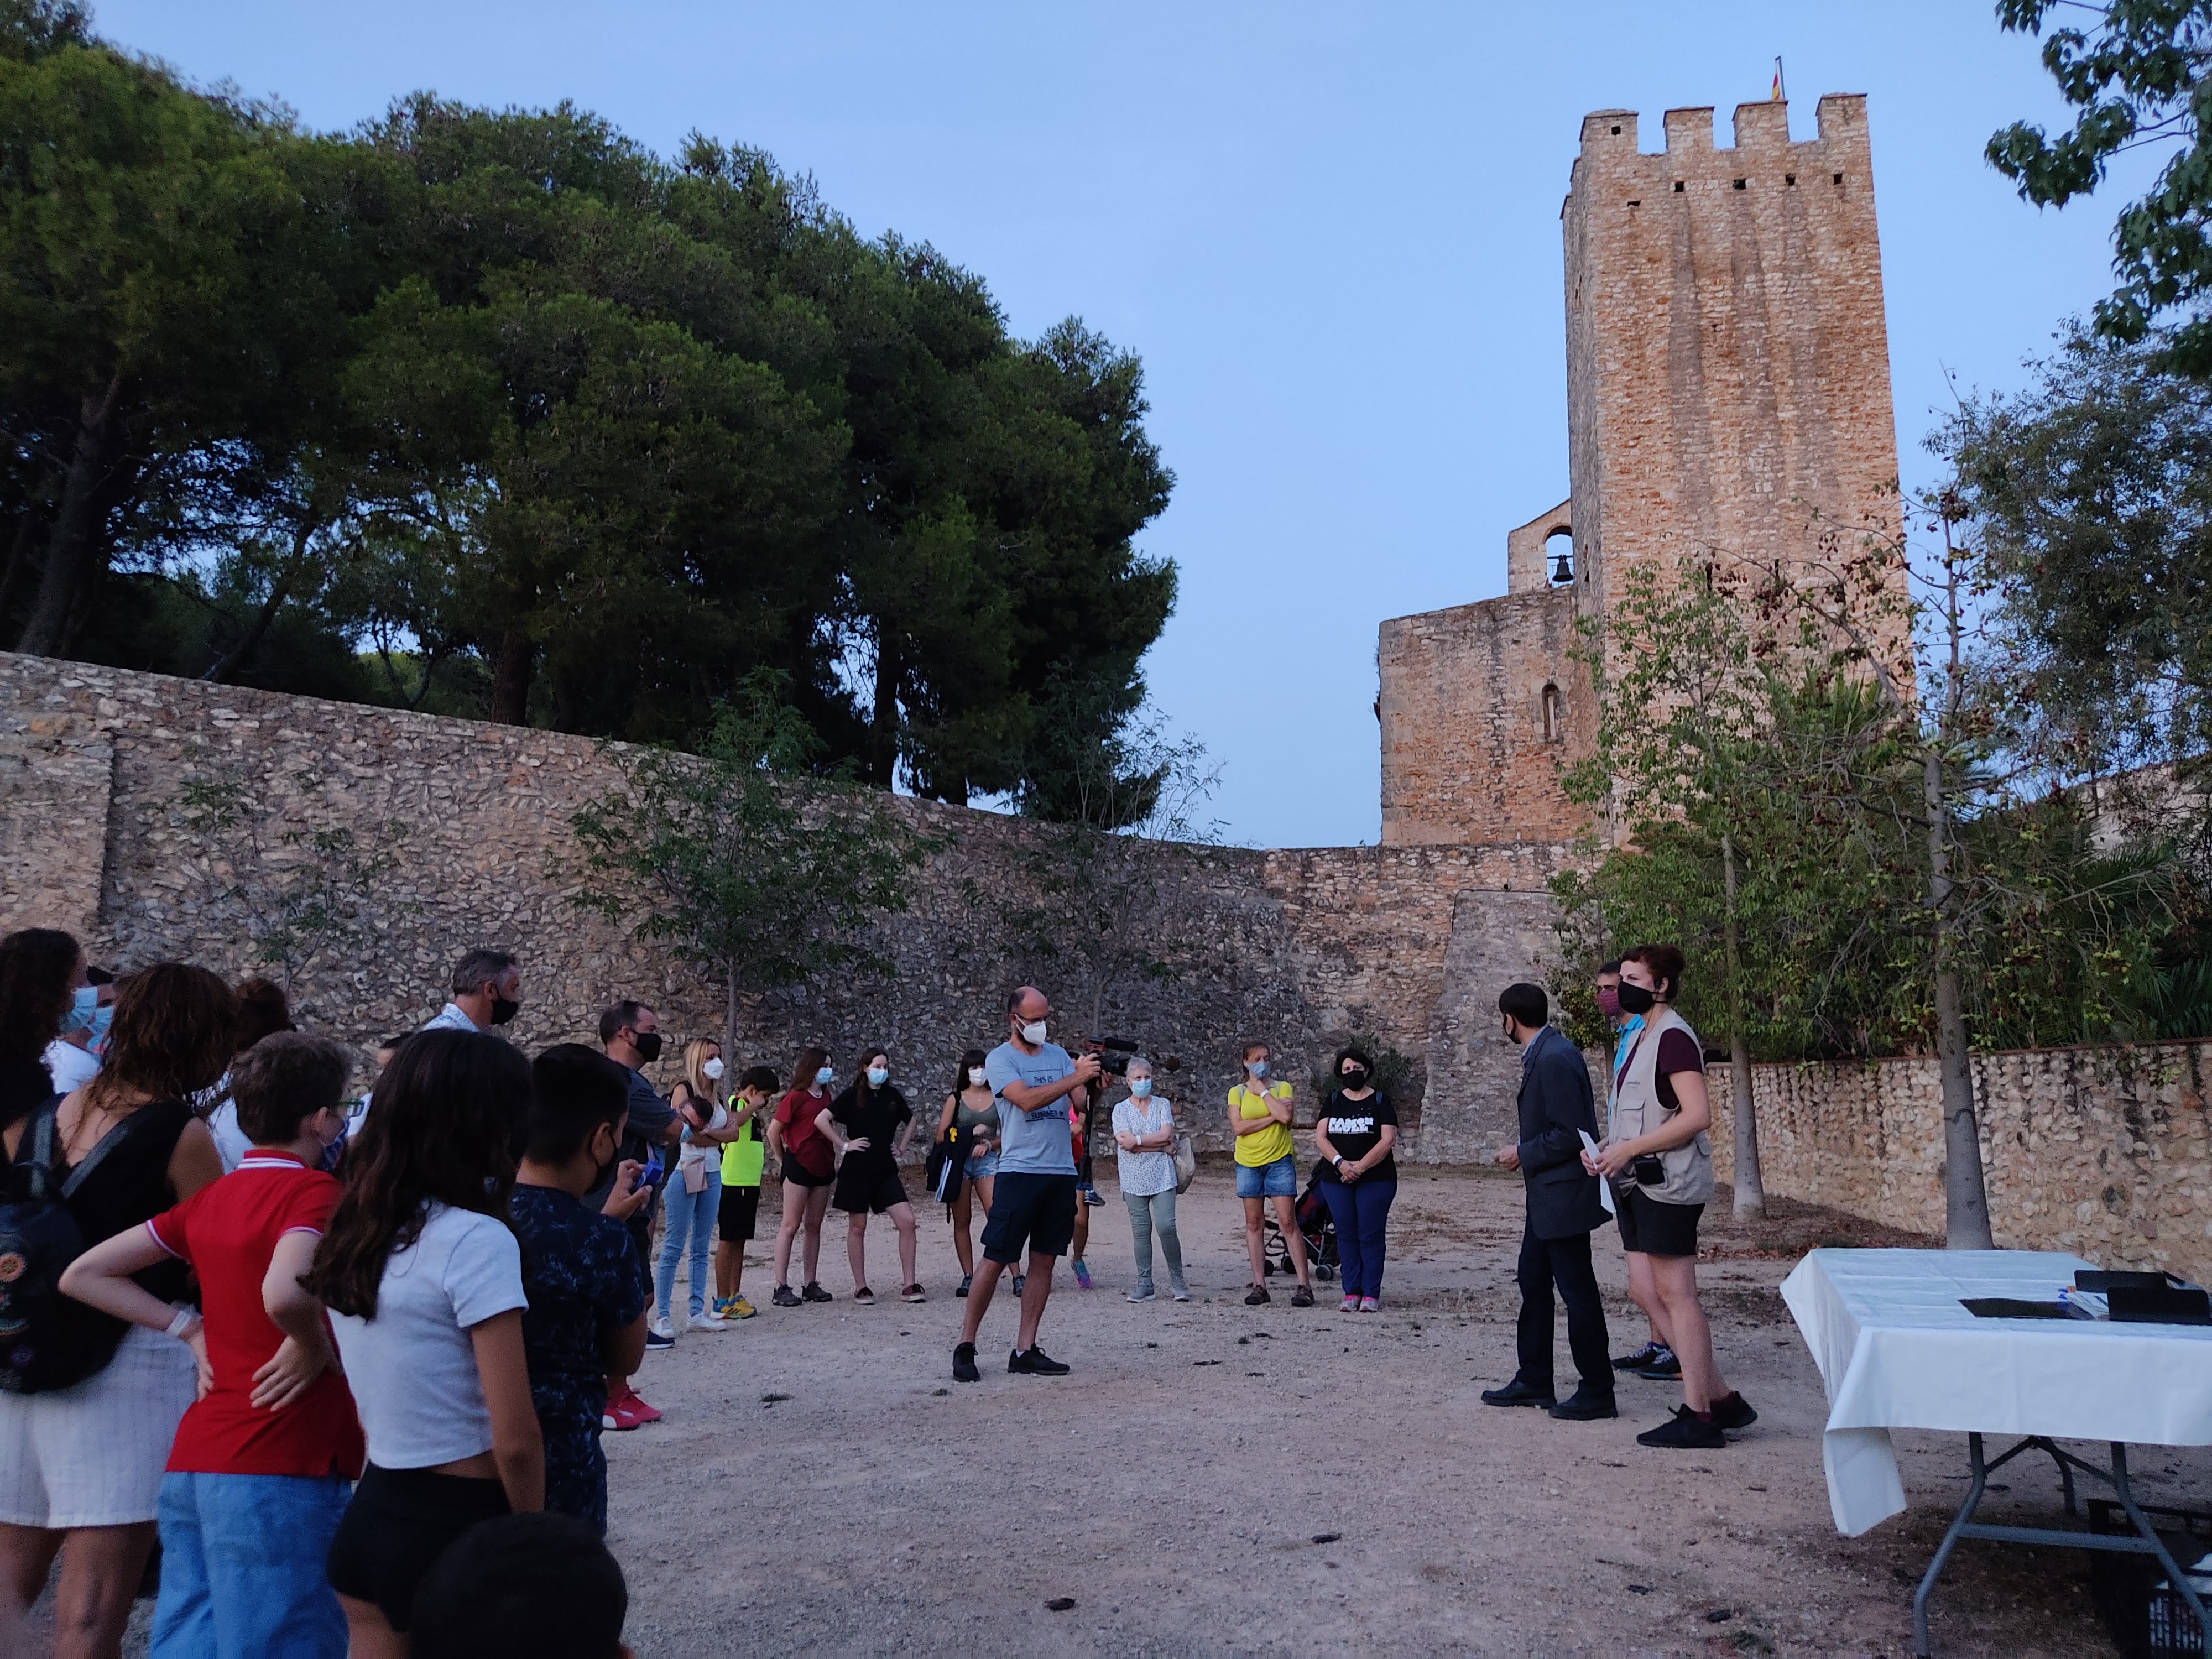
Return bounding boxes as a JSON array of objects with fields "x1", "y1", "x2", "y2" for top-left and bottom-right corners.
[{"x1": 39, "y1": 1166, "x2": 2212, "y2": 1659}]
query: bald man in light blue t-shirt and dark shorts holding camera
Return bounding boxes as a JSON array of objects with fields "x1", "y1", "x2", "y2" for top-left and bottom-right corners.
[{"x1": 953, "y1": 984, "x2": 1099, "y2": 1383}]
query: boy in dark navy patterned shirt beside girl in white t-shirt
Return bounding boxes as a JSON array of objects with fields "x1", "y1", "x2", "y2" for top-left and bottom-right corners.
[{"x1": 511, "y1": 1042, "x2": 650, "y2": 1533}]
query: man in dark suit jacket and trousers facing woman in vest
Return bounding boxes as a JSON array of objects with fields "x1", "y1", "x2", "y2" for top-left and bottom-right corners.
[{"x1": 1482, "y1": 984, "x2": 1619, "y2": 1422}]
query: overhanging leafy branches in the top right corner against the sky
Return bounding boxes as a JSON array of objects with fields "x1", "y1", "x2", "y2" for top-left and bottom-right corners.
[{"x1": 1989, "y1": 0, "x2": 2212, "y2": 374}]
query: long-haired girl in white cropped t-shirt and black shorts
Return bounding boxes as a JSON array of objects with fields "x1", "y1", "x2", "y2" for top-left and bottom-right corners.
[{"x1": 307, "y1": 1031, "x2": 544, "y2": 1659}]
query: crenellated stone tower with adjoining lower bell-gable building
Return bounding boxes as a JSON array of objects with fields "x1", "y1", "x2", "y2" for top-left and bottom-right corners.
[{"x1": 1376, "y1": 95, "x2": 1898, "y2": 843}]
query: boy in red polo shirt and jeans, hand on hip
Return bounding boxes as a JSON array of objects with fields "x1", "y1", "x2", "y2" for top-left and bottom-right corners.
[{"x1": 62, "y1": 1031, "x2": 363, "y2": 1659}]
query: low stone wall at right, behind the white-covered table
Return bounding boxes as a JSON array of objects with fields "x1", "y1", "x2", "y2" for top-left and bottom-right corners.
[{"x1": 1708, "y1": 1042, "x2": 2212, "y2": 1283}]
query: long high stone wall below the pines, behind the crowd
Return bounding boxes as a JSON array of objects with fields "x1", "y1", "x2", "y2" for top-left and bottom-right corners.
[{"x1": 0, "y1": 655, "x2": 1559, "y2": 1159}]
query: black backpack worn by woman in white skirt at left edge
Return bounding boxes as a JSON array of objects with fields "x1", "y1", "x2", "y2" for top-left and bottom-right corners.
[{"x1": 0, "y1": 1110, "x2": 133, "y2": 1394}]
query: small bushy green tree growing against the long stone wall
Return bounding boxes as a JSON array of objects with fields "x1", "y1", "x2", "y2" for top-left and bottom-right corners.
[{"x1": 568, "y1": 670, "x2": 938, "y2": 1055}]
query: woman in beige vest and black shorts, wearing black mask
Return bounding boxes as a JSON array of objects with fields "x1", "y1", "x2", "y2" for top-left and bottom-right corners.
[{"x1": 1582, "y1": 945, "x2": 1759, "y2": 1449}]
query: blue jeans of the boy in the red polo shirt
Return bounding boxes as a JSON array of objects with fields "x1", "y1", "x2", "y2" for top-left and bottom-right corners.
[{"x1": 153, "y1": 1473, "x2": 354, "y2": 1659}]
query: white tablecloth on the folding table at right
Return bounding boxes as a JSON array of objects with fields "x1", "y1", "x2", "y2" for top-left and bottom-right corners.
[{"x1": 1783, "y1": 1250, "x2": 2212, "y2": 1537}]
